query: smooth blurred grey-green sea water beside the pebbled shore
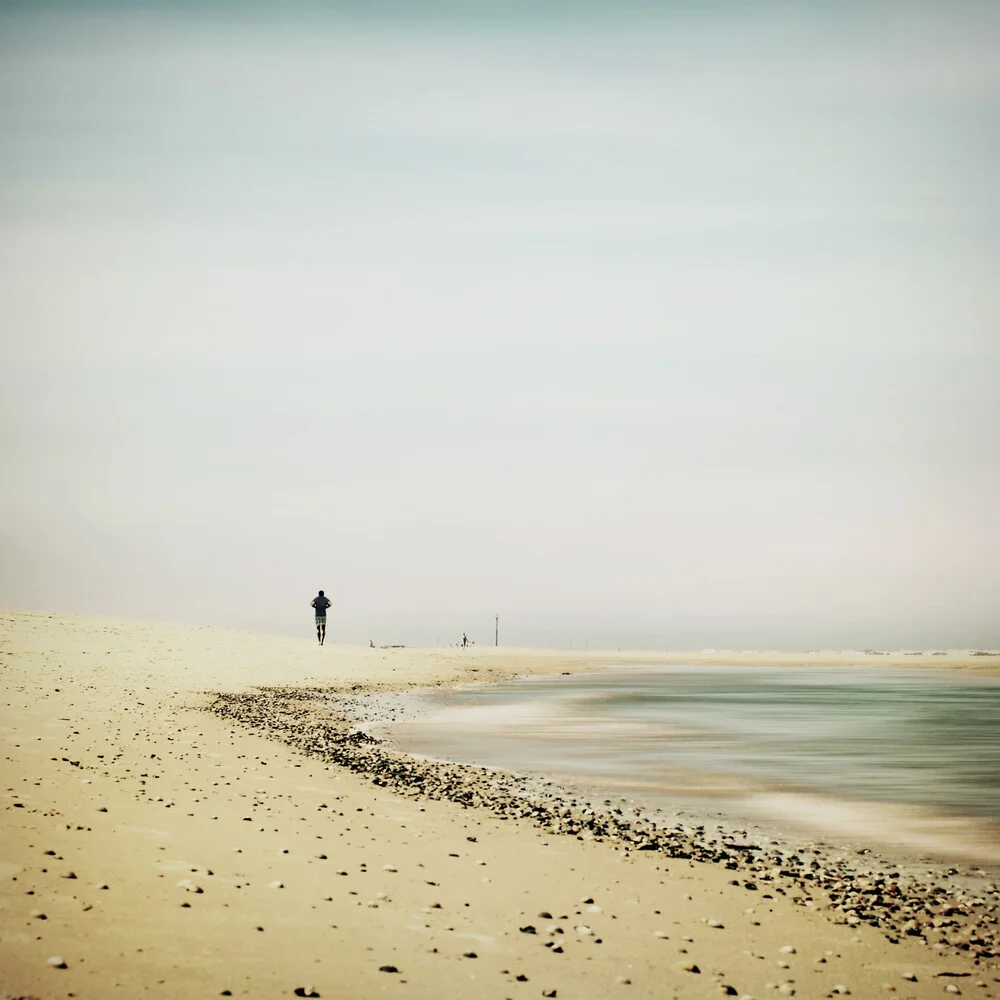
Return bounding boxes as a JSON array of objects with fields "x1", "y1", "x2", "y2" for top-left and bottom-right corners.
[{"x1": 383, "y1": 664, "x2": 1000, "y2": 870}]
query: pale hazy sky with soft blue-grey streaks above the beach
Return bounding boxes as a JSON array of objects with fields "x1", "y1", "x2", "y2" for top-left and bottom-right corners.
[{"x1": 0, "y1": 0, "x2": 1000, "y2": 649}]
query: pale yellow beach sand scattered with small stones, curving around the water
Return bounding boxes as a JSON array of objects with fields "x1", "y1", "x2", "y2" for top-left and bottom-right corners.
[{"x1": 0, "y1": 613, "x2": 1000, "y2": 1000}]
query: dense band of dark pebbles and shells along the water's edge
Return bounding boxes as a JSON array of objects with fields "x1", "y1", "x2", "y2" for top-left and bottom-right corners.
[{"x1": 208, "y1": 687, "x2": 1000, "y2": 959}]
